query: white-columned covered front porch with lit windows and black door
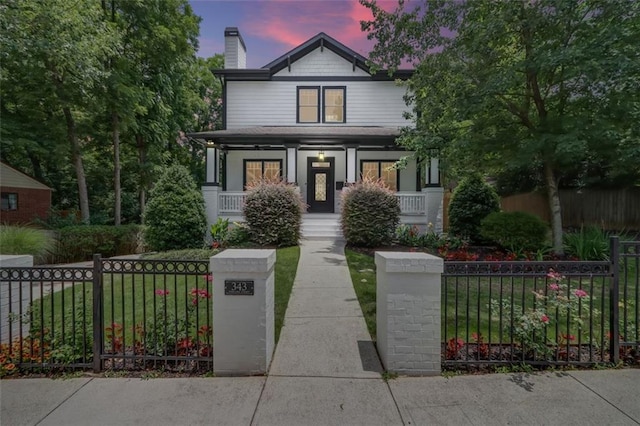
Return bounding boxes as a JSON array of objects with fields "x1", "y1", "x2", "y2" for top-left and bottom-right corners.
[{"x1": 190, "y1": 126, "x2": 443, "y2": 235}]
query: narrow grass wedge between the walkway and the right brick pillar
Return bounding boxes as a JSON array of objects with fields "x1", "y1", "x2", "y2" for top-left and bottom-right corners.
[{"x1": 345, "y1": 249, "x2": 376, "y2": 341}]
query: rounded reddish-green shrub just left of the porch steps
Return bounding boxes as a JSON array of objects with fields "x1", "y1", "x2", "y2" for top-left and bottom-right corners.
[{"x1": 243, "y1": 180, "x2": 305, "y2": 247}]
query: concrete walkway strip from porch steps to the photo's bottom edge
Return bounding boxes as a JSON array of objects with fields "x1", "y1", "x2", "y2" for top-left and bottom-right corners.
[{"x1": 254, "y1": 240, "x2": 402, "y2": 425}]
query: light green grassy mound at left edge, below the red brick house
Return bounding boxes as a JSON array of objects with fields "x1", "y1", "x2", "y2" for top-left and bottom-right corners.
[{"x1": 0, "y1": 225, "x2": 53, "y2": 264}]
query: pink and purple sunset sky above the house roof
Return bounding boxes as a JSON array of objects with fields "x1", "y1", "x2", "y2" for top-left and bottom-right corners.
[{"x1": 189, "y1": 0, "x2": 396, "y2": 68}]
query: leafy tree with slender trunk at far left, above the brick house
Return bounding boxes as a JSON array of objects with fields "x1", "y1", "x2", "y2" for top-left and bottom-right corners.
[{"x1": 0, "y1": 0, "x2": 116, "y2": 222}]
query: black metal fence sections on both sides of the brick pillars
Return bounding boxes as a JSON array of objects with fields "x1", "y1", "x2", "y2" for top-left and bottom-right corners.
[{"x1": 0, "y1": 238, "x2": 640, "y2": 377}]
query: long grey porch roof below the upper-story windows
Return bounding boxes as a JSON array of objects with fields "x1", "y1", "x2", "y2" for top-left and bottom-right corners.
[{"x1": 187, "y1": 126, "x2": 400, "y2": 146}]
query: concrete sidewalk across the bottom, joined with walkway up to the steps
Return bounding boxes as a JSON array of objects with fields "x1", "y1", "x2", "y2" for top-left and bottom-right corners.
[{"x1": 0, "y1": 240, "x2": 640, "y2": 426}]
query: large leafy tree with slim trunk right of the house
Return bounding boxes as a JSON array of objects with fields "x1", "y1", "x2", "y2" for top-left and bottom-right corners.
[{"x1": 361, "y1": 0, "x2": 640, "y2": 254}]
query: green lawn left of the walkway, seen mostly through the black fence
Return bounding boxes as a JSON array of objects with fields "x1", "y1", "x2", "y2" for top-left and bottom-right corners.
[{"x1": 32, "y1": 246, "x2": 300, "y2": 349}]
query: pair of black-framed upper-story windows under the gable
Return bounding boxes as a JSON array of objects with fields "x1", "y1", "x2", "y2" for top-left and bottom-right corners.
[{"x1": 297, "y1": 86, "x2": 347, "y2": 123}]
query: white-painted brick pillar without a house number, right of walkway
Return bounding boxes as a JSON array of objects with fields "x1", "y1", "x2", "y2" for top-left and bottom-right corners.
[{"x1": 376, "y1": 252, "x2": 444, "y2": 376}]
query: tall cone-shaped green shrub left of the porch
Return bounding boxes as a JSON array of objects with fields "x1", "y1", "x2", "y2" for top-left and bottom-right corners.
[{"x1": 144, "y1": 165, "x2": 207, "y2": 250}]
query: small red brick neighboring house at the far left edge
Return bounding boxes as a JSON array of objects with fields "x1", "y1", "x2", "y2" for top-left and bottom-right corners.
[{"x1": 0, "y1": 163, "x2": 51, "y2": 224}]
